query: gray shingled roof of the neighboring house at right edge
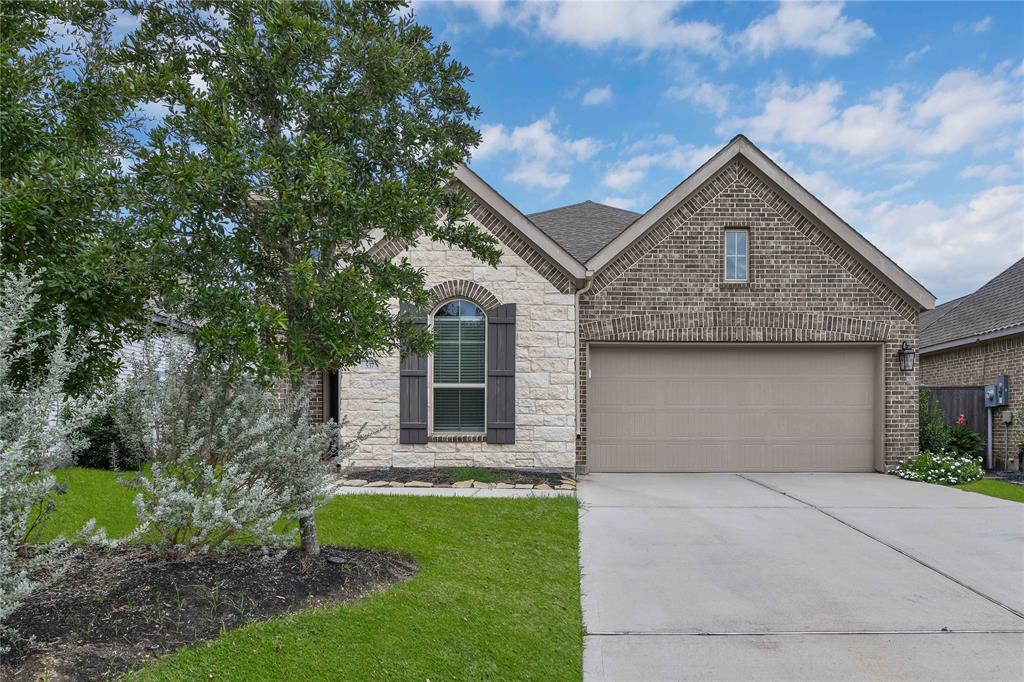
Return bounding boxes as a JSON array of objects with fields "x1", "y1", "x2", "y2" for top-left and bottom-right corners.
[{"x1": 921, "y1": 258, "x2": 1024, "y2": 348}]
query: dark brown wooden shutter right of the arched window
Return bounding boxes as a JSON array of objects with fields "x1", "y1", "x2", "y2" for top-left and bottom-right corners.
[{"x1": 487, "y1": 303, "x2": 515, "y2": 443}]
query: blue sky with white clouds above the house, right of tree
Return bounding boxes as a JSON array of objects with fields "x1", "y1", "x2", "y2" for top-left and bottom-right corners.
[{"x1": 414, "y1": 1, "x2": 1024, "y2": 301}]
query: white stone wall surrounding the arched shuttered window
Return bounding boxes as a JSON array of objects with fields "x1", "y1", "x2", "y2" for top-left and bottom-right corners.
[{"x1": 340, "y1": 206, "x2": 575, "y2": 469}]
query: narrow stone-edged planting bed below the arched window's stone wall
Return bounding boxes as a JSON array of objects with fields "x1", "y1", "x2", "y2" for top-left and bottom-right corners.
[{"x1": 338, "y1": 467, "x2": 575, "y2": 491}]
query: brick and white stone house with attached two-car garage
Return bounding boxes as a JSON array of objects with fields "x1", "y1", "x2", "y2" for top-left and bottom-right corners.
[{"x1": 326, "y1": 136, "x2": 934, "y2": 472}]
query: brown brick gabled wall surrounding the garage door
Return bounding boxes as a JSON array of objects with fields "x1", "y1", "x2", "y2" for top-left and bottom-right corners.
[{"x1": 577, "y1": 160, "x2": 918, "y2": 468}]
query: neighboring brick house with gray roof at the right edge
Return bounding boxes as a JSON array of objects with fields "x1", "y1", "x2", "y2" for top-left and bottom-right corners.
[{"x1": 921, "y1": 259, "x2": 1024, "y2": 469}]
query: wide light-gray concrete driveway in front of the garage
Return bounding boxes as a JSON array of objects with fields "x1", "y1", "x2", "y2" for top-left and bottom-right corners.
[{"x1": 580, "y1": 474, "x2": 1024, "y2": 680}]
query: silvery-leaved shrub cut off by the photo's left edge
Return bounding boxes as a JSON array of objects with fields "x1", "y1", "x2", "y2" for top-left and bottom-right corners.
[{"x1": 0, "y1": 272, "x2": 101, "y2": 652}]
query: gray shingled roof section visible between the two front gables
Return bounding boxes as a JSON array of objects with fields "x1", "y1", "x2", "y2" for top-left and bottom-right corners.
[{"x1": 526, "y1": 201, "x2": 640, "y2": 263}]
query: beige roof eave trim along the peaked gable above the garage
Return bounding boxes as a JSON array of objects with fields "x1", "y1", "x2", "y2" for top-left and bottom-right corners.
[{"x1": 586, "y1": 135, "x2": 935, "y2": 310}]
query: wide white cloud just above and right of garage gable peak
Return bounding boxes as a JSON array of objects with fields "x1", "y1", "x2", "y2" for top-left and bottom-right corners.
[{"x1": 718, "y1": 70, "x2": 1024, "y2": 158}]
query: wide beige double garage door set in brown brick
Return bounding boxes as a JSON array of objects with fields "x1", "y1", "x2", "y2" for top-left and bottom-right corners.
[{"x1": 588, "y1": 344, "x2": 880, "y2": 471}]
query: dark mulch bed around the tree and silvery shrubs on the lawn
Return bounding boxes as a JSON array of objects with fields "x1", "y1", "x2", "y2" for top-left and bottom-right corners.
[{"x1": 0, "y1": 546, "x2": 417, "y2": 680}]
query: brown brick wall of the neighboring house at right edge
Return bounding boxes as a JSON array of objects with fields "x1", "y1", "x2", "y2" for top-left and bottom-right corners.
[{"x1": 920, "y1": 334, "x2": 1024, "y2": 469}]
